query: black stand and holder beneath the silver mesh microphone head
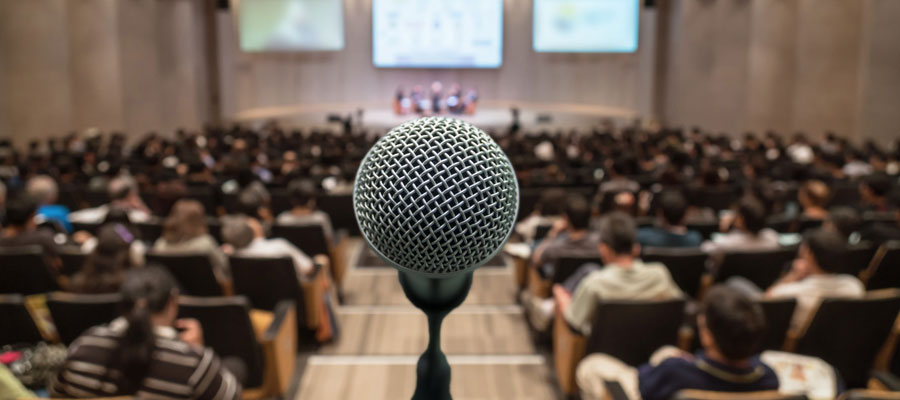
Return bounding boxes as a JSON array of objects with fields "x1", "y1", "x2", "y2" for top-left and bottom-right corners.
[{"x1": 399, "y1": 270, "x2": 473, "y2": 400}]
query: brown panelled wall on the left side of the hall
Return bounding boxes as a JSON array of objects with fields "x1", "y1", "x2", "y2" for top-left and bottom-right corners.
[{"x1": 0, "y1": 0, "x2": 208, "y2": 142}]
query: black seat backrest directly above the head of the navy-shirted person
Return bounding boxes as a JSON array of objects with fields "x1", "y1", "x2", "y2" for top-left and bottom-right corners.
[{"x1": 716, "y1": 247, "x2": 797, "y2": 290}]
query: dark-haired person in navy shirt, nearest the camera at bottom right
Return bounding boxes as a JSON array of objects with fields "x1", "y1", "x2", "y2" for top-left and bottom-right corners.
[{"x1": 576, "y1": 286, "x2": 778, "y2": 400}]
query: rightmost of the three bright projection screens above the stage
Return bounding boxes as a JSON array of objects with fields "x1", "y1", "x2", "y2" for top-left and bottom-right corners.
[{"x1": 533, "y1": 0, "x2": 640, "y2": 53}]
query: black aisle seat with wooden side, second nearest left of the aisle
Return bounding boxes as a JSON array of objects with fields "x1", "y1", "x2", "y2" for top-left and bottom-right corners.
[{"x1": 229, "y1": 256, "x2": 323, "y2": 338}]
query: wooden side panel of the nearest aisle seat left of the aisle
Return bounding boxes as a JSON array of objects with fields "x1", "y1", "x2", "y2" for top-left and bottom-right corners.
[{"x1": 244, "y1": 300, "x2": 297, "y2": 398}]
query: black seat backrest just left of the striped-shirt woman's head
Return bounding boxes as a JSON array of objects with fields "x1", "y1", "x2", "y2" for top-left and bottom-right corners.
[{"x1": 47, "y1": 292, "x2": 122, "y2": 346}]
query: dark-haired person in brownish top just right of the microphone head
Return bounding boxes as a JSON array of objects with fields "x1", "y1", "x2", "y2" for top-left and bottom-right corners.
[{"x1": 531, "y1": 196, "x2": 598, "y2": 276}]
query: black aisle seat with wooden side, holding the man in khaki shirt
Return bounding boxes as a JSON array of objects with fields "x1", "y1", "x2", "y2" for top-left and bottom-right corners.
[{"x1": 553, "y1": 299, "x2": 686, "y2": 395}]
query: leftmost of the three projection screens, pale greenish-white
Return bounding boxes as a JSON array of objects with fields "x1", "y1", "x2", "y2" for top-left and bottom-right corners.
[{"x1": 237, "y1": 0, "x2": 344, "y2": 52}]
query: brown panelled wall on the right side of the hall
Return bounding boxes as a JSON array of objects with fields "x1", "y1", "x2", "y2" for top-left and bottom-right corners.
[{"x1": 660, "y1": 0, "x2": 900, "y2": 141}]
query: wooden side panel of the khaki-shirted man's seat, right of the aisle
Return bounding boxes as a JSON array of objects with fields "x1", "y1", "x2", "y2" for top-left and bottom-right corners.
[{"x1": 553, "y1": 307, "x2": 587, "y2": 396}]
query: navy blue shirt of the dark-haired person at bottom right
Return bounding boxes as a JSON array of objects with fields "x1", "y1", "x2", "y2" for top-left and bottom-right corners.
[{"x1": 638, "y1": 351, "x2": 778, "y2": 400}]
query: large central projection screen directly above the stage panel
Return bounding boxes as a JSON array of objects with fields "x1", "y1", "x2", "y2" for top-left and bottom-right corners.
[{"x1": 372, "y1": 0, "x2": 503, "y2": 68}]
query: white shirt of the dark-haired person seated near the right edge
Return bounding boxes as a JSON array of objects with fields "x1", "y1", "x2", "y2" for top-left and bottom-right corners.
[{"x1": 771, "y1": 274, "x2": 866, "y2": 330}]
